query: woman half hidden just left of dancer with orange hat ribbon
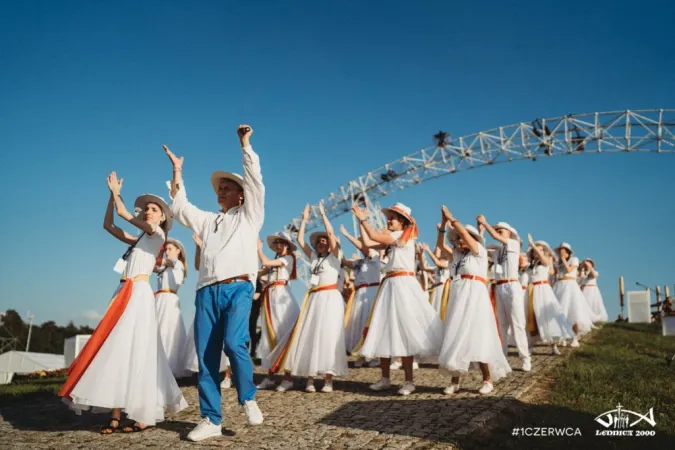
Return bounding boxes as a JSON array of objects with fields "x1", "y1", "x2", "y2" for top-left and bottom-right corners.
[{"x1": 340, "y1": 226, "x2": 382, "y2": 367}]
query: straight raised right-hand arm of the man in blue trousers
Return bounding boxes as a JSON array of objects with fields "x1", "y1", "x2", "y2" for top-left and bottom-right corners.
[{"x1": 237, "y1": 125, "x2": 265, "y2": 227}]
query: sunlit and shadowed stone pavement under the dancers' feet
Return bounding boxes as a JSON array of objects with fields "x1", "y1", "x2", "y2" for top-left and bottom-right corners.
[{"x1": 0, "y1": 346, "x2": 571, "y2": 450}]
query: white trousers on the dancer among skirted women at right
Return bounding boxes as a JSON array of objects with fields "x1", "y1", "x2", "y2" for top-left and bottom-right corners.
[{"x1": 495, "y1": 281, "x2": 530, "y2": 358}]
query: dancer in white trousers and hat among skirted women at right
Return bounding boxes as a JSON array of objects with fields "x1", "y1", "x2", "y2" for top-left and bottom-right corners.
[{"x1": 477, "y1": 215, "x2": 532, "y2": 372}]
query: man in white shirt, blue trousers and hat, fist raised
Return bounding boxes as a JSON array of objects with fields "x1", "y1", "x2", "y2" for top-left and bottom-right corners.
[{"x1": 164, "y1": 125, "x2": 265, "y2": 441}]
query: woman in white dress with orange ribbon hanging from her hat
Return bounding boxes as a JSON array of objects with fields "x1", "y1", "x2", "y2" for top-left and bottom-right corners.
[{"x1": 352, "y1": 203, "x2": 443, "y2": 395}]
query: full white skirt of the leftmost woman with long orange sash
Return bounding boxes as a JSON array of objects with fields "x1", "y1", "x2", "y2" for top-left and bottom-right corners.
[{"x1": 65, "y1": 281, "x2": 187, "y2": 425}]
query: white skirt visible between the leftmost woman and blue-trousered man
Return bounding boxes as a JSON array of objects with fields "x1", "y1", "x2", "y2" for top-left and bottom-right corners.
[{"x1": 155, "y1": 292, "x2": 187, "y2": 378}]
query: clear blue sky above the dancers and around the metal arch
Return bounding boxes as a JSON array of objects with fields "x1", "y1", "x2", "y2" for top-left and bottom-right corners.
[{"x1": 0, "y1": 0, "x2": 675, "y2": 325}]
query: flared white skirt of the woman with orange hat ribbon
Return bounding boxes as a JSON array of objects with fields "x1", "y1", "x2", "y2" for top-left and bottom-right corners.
[{"x1": 360, "y1": 276, "x2": 443, "y2": 359}]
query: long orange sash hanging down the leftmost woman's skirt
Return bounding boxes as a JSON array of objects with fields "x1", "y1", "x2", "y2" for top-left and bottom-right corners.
[{"x1": 58, "y1": 275, "x2": 149, "y2": 400}]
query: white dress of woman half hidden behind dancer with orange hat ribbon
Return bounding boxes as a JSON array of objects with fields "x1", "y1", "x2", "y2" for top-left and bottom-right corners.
[{"x1": 345, "y1": 255, "x2": 382, "y2": 353}]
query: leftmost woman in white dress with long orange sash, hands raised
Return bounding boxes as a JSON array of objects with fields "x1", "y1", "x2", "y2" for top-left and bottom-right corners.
[{"x1": 59, "y1": 172, "x2": 187, "y2": 434}]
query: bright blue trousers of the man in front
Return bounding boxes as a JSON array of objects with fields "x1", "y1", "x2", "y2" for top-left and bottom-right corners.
[{"x1": 195, "y1": 281, "x2": 256, "y2": 425}]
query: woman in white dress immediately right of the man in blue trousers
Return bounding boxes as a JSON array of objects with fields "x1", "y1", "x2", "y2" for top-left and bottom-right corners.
[{"x1": 258, "y1": 233, "x2": 300, "y2": 392}]
